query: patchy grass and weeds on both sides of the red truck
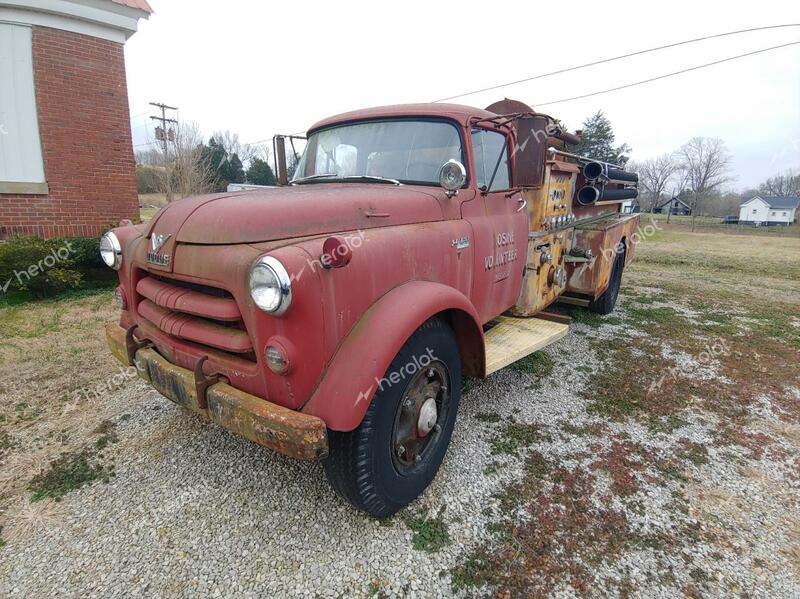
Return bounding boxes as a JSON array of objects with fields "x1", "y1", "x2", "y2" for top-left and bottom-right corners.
[{"x1": 0, "y1": 224, "x2": 800, "y2": 597}]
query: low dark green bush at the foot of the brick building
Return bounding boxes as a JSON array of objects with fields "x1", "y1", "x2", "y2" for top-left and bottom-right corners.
[{"x1": 0, "y1": 237, "x2": 116, "y2": 299}]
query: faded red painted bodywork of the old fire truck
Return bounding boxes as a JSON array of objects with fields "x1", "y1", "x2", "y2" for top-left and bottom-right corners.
[{"x1": 109, "y1": 98, "x2": 636, "y2": 453}]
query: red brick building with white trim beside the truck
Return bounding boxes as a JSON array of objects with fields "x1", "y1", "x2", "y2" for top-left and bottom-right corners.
[{"x1": 0, "y1": 0, "x2": 152, "y2": 239}]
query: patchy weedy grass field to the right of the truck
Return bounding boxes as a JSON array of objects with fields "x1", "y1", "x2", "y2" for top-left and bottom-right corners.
[{"x1": 452, "y1": 225, "x2": 800, "y2": 597}]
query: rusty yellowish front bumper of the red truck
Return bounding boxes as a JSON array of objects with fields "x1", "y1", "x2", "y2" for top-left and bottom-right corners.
[{"x1": 106, "y1": 323, "x2": 328, "y2": 460}]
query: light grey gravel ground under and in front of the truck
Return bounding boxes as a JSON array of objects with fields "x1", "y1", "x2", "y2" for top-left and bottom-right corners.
[{"x1": 0, "y1": 308, "x2": 800, "y2": 598}]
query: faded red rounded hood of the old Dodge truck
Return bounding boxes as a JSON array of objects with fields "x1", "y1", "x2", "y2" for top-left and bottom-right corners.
[{"x1": 146, "y1": 183, "x2": 443, "y2": 245}]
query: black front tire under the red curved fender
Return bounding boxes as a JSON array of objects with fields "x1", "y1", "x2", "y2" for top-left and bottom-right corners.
[{"x1": 324, "y1": 317, "x2": 461, "y2": 518}]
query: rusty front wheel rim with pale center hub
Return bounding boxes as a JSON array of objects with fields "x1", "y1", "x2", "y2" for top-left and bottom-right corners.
[{"x1": 392, "y1": 360, "x2": 450, "y2": 474}]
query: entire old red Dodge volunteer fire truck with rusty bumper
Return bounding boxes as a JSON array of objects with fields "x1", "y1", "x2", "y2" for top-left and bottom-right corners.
[{"x1": 101, "y1": 100, "x2": 638, "y2": 517}]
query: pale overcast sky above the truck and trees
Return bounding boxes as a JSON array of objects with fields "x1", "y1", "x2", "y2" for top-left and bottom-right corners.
[{"x1": 125, "y1": 0, "x2": 800, "y2": 188}]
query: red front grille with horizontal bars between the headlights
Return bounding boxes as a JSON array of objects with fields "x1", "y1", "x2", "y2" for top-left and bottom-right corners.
[{"x1": 136, "y1": 274, "x2": 255, "y2": 361}]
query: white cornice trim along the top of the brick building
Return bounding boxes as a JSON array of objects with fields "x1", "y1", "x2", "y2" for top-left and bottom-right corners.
[{"x1": 0, "y1": 0, "x2": 149, "y2": 44}]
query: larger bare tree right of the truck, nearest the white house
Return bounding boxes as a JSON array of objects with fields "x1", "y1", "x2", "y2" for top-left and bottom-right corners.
[{"x1": 678, "y1": 137, "x2": 731, "y2": 231}]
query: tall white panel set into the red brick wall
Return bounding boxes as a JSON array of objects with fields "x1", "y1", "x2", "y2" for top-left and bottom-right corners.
[{"x1": 0, "y1": 23, "x2": 45, "y2": 183}]
